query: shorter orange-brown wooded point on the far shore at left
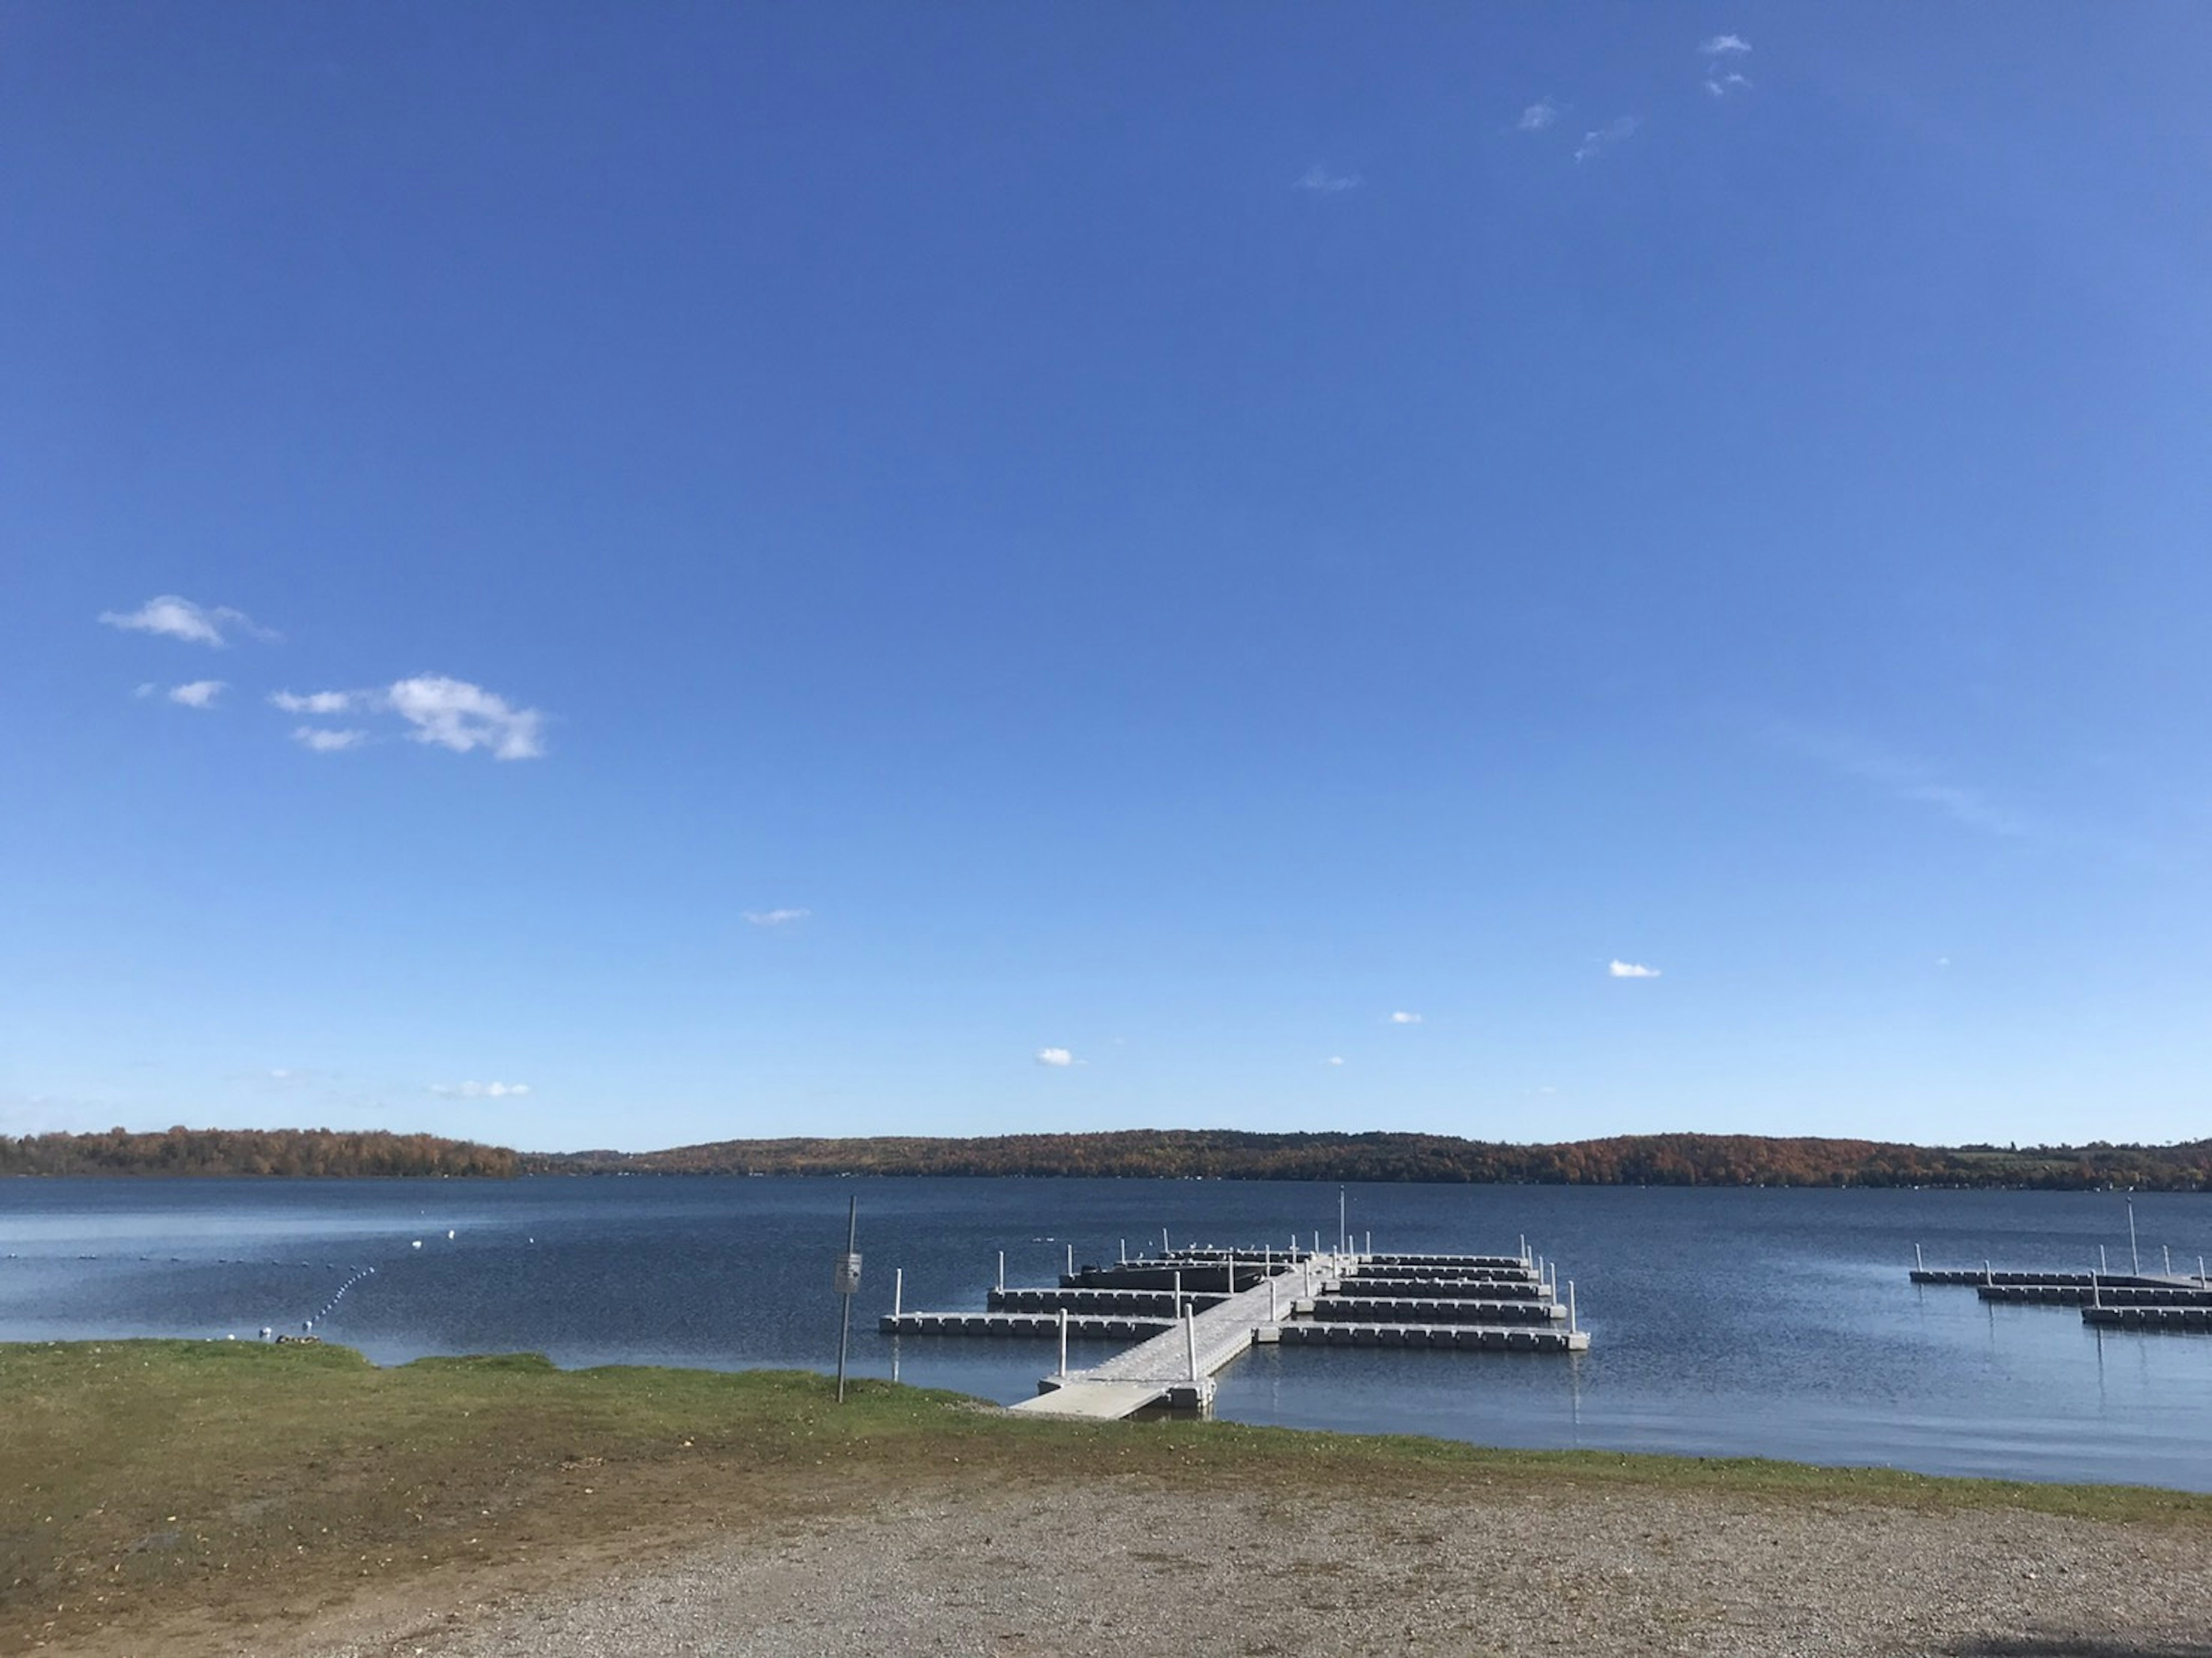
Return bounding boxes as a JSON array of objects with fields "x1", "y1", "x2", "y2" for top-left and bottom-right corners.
[{"x1": 0, "y1": 1128, "x2": 518, "y2": 1176}]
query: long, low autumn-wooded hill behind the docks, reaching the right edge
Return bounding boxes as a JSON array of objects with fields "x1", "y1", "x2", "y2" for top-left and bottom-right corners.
[{"x1": 520, "y1": 1130, "x2": 2212, "y2": 1192}]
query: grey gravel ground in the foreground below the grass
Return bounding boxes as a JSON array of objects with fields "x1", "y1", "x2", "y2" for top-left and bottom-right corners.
[{"x1": 308, "y1": 1481, "x2": 2212, "y2": 1658}]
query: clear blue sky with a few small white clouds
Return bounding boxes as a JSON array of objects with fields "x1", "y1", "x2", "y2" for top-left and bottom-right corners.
[{"x1": 0, "y1": 0, "x2": 2212, "y2": 1147}]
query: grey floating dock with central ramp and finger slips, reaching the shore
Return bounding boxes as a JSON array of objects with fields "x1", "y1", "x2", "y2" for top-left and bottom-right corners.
[{"x1": 882, "y1": 1247, "x2": 1590, "y2": 1417}]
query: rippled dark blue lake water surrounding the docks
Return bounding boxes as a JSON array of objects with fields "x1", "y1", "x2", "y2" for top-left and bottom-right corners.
[{"x1": 0, "y1": 1178, "x2": 2212, "y2": 1490}]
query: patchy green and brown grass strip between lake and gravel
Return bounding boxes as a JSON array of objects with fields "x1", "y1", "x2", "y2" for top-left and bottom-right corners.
[{"x1": 0, "y1": 1342, "x2": 2212, "y2": 1651}]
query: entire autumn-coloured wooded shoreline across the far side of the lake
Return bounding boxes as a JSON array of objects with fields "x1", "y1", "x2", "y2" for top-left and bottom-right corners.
[{"x1": 0, "y1": 1128, "x2": 2212, "y2": 1192}]
